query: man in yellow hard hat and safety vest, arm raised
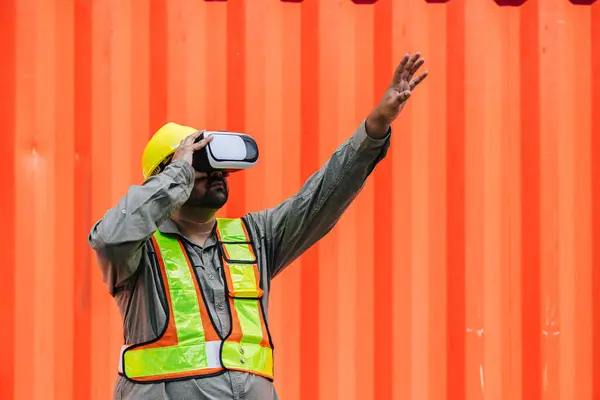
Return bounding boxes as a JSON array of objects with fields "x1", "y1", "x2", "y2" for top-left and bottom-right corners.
[{"x1": 89, "y1": 53, "x2": 427, "y2": 400}]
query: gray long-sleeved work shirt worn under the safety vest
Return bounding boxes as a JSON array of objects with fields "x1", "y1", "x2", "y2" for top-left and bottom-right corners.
[{"x1": 89, "y1": 121, "x2": 391, "y2": 400}]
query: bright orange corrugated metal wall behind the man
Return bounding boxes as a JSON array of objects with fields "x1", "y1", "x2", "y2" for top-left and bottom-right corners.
[{"x1": 0, "y1": 0, "x2": 600, "y2": 400}]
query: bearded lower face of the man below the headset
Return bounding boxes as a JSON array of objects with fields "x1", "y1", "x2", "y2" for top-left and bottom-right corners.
[{"x1": 185, "y1": 171, "x2": 229, "y2": 210}]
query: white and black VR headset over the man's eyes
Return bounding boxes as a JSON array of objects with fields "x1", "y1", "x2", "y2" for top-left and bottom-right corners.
[{"x1": 193, "y1": 131, "x2": 258, "y2": 172}]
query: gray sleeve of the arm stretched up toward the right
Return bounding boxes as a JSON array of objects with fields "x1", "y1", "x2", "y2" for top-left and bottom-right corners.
[{"x1": 252, "y1": 121, "x2": 391, "y2": 279}]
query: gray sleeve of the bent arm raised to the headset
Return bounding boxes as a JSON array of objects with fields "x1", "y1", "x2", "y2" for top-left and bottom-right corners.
[{"x1": 88, "y1": 160, "x2": 194, "y2": 294}]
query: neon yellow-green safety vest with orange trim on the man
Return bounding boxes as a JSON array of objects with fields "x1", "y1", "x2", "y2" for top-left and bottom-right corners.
[{"x1": 119, "y1": 218, "x2": 273, "y2": 382}]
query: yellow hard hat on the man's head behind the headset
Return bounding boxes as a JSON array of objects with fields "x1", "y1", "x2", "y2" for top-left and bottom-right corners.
[{"x1": 142, "y1": 122, "x2": 197, "y2": 180}]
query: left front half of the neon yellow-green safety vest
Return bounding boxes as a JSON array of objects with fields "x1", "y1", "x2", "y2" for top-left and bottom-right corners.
[{"x1": 120, "y1": 232, "x2": 223, "y2": 382}]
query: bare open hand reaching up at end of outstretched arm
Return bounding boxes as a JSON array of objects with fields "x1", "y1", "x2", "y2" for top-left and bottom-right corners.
[{"x1": 366, "y1": 53, "x2": 428, "y2": 139}]
